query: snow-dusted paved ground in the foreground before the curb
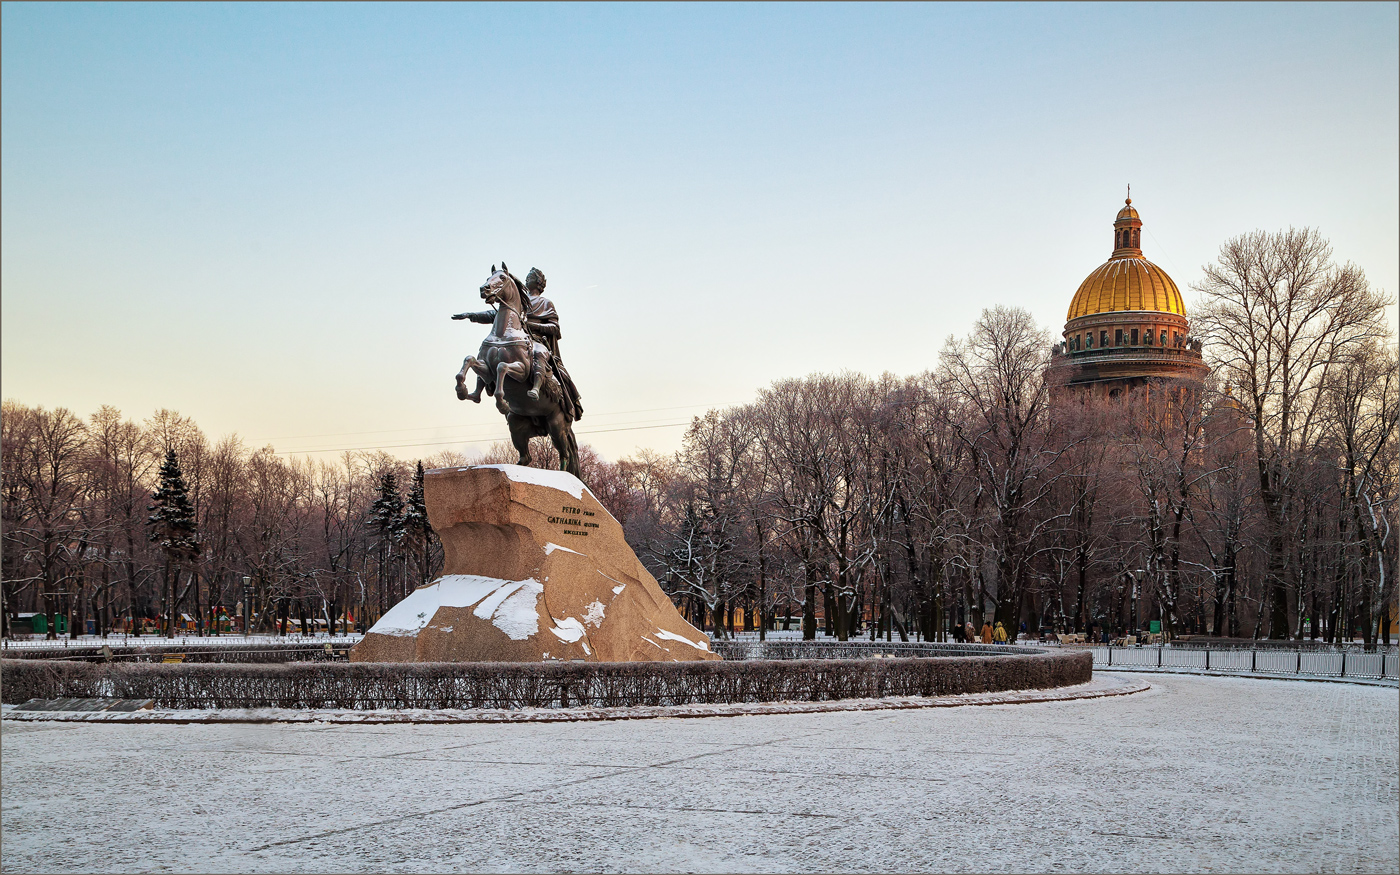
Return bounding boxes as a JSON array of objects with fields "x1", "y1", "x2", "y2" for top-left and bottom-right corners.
[{"x1": 0, "y1": 673, "x2": 1400, "y2": 872}]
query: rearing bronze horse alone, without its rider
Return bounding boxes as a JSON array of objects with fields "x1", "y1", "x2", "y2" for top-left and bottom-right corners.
[{"x1": 456, "y1": 265, "x2": 581, "y2": 477}]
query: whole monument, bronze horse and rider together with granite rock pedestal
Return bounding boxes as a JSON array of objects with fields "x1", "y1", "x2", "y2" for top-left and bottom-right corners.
[{"x1": 350, "y1": 263, "x2": 718, "y2": 662}]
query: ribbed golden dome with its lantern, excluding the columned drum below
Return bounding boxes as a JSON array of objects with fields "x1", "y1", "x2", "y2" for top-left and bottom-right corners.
[{"x1": 1068, "y1": 199, "x2": 1186, "y2": 319}]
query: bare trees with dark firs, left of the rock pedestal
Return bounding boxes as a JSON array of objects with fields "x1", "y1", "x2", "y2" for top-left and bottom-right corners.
[{"x1": 0, "y1": 400, "x2": 445, "y2": 637}]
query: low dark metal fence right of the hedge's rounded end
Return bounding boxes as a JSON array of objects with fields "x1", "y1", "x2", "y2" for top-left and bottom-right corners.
[{"x1": 1084, "y1": 645, "x2": 1400, "y2": 680}]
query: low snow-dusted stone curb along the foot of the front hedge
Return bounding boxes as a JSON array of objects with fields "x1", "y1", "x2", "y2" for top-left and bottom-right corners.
[{"x1": 0, "y1": 675, "x2": 1152, "y2": 725}]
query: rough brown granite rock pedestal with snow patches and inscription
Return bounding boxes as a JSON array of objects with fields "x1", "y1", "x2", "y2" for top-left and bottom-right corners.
[{"x1": 350, "y1": 465, "x2": 718, "y2": 662}]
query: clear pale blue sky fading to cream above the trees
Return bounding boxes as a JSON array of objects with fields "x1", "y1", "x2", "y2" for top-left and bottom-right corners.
[{"x1": 0, "y1": 3, "x2": 1400, "y2": 458}]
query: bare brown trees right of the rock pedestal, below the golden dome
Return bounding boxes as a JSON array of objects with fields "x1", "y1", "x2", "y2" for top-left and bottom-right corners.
[{"x1": 620, "y1": 230, "x2": 1397, "y2": 641}]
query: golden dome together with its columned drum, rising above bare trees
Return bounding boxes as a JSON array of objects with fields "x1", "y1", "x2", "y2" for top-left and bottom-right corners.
[{"x1": 1050, "y1": 197, "x2": 1207, "y2": 396}]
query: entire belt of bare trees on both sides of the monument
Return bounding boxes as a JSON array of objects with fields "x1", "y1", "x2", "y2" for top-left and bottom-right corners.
[{"x1": 0, "y1": 230, "x2": 1400, "y2": 641}]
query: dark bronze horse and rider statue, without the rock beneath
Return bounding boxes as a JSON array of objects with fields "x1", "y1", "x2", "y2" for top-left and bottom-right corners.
[{"x1": 452, "y1": 262, "x2": 584, "y2": 477}]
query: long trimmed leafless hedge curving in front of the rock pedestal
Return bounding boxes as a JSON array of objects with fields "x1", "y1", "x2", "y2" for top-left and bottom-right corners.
[{"x1": 0, "y1": 652, "x2": 1093, "y2": 710}]
